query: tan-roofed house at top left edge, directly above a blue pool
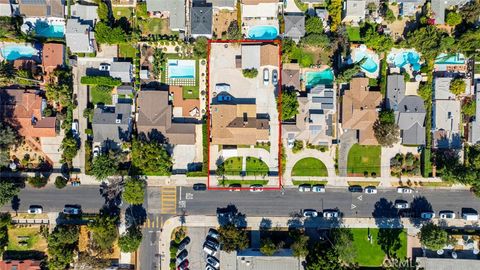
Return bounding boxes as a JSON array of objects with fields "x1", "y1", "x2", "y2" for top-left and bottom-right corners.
[{"x1": 18, "y1": 0, "x2": 65, "y2": 19}]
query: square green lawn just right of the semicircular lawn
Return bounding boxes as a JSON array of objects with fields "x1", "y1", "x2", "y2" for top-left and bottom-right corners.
[{"x1": 347, "y1": 144, "x2": 381, "y2": 176}]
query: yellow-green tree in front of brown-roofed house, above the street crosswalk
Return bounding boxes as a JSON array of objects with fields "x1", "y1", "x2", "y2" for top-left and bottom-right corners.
[{"x1": 132, "y1": 139, "x2": 173, "y2": 175}]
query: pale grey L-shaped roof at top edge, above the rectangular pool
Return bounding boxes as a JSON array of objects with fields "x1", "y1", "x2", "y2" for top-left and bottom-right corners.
[{"x1": 147, "y1": 0, "x2": 186, "y2": 32}]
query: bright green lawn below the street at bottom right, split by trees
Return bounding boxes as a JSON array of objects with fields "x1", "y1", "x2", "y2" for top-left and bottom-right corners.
[{"x1": 351, "y1": 229, "x2": 407, "y2": 267}]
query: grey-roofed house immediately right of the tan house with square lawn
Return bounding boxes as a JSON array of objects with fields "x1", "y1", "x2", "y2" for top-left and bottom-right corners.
[{"x1": 386, "y1": 74, "x2": 426, "y2": 145}]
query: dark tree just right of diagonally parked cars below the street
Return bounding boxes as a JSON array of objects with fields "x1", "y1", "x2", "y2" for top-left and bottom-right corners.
[{"x1": 218, "y1": 224, "x2": 248, "y2": 252}]
